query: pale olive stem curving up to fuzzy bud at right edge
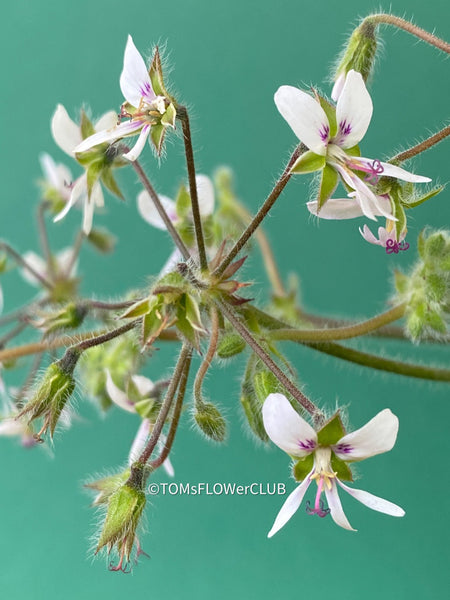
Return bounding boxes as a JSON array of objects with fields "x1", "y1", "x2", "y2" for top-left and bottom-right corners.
[{"x1": 271, "y1": 304, "x2": 406, "y2": 342}]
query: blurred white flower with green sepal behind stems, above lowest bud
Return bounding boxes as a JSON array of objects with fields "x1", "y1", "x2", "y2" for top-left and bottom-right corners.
[{"x1": 106, "y1": 371, "x2": 175, "y2": 477}]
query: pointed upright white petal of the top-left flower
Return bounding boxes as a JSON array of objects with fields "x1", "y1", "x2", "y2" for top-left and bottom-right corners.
[{"x1": 120, "y1": 35, "x2": 155, "y2": 108}]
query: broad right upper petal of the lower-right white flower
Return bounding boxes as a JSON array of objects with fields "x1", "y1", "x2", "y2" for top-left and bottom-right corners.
[{"x1": 333, "y1": 408, "x2": 398, "y2": 461}]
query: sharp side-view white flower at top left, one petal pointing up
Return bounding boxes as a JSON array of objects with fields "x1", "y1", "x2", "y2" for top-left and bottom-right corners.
[{"x1": 75, "y1": 35, "x2": 176, "y2": 161}]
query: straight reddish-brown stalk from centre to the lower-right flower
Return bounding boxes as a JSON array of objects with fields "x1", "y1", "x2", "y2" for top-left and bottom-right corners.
[{"x1": 216, "y1": 300, "x2": 323, "y2": 421}]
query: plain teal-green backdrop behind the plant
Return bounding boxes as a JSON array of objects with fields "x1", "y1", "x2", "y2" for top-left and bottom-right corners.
[{"x1": 0, "y1": 0, "x2": 450, "y2": 600}]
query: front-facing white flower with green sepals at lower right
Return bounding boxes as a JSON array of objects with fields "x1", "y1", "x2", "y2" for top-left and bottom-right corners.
[{"x1": 263, "y1": 394, "x2": 405, "y2": 537}]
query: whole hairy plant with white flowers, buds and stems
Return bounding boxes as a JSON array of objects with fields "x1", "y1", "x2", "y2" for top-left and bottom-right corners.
[{"x1": 0, "y1": 15, "x2": 450, "y2": 572}]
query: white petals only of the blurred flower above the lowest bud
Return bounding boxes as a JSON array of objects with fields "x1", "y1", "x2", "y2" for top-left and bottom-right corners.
[{"x1": 106, "y1": 371, "x2": 175, "y2": 477}]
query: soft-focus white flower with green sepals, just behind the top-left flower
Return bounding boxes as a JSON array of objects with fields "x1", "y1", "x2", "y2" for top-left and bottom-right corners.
[{"x1": 47, "y1": 104, "x2": 125, "y2": 235}]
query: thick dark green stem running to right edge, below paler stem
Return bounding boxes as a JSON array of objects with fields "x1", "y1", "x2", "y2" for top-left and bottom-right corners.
[{"x1": 305, "y1": 342, "x2": 450, "y2": 381}]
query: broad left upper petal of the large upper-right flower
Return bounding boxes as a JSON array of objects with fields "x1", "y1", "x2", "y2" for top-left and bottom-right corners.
[{"x1": 275, "y1": 85, "x2": 330, "y2": 156}]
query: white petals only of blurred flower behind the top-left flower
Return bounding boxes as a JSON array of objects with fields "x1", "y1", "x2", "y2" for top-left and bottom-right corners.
[{"x1": 51, "y1": 104, "x2": 117, "y2": 235}]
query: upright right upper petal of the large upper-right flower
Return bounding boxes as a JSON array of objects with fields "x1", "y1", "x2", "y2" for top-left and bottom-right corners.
[{"x1": 335, "y1": 69, "x2": 373, "y2": 148}]
